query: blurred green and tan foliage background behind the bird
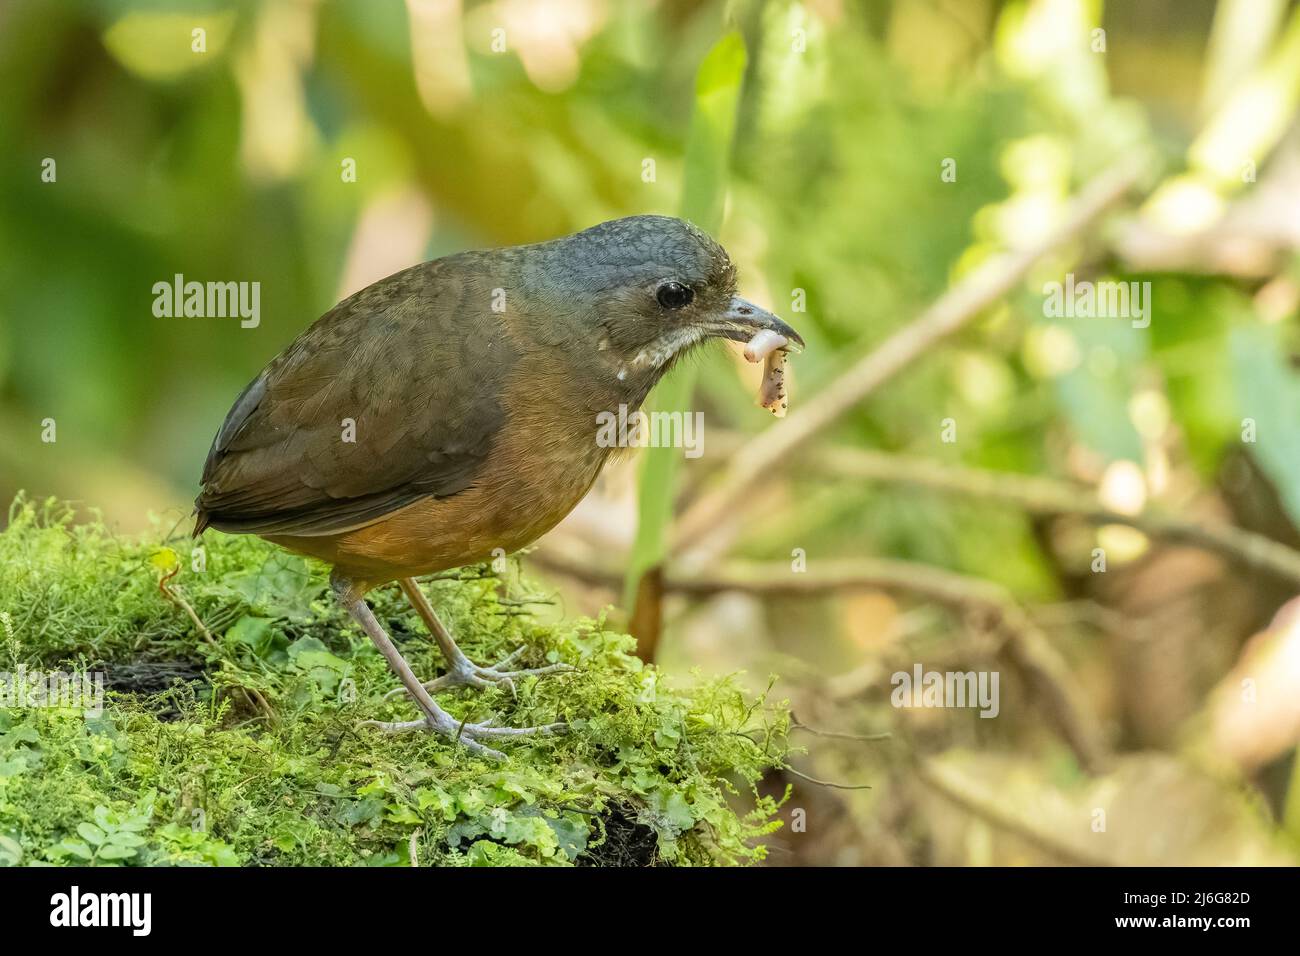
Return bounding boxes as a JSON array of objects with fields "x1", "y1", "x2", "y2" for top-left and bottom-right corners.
[{"x1": 0, "y1": 0, "x2": 1300, "y2": 864}]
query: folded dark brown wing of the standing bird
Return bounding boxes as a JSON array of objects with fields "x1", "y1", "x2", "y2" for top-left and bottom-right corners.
[{"x1": 195, "y1": 263, "x2": 514, "y2": 536}]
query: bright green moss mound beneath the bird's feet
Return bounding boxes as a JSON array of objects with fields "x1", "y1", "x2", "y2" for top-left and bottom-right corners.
[{"x1": 0, "y1": 498, "x2": 788, "y2": 865}]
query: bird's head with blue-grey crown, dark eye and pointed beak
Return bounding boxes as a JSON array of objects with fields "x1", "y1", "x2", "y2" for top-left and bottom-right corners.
[{"x1": 530, "y1": 216, "x2": 803, "y2": 385}]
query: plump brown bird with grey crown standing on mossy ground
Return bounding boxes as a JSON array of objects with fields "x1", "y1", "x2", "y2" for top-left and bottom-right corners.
[{"x1": 194, "y1": 216, "x2": 803, "y2": 758}]
